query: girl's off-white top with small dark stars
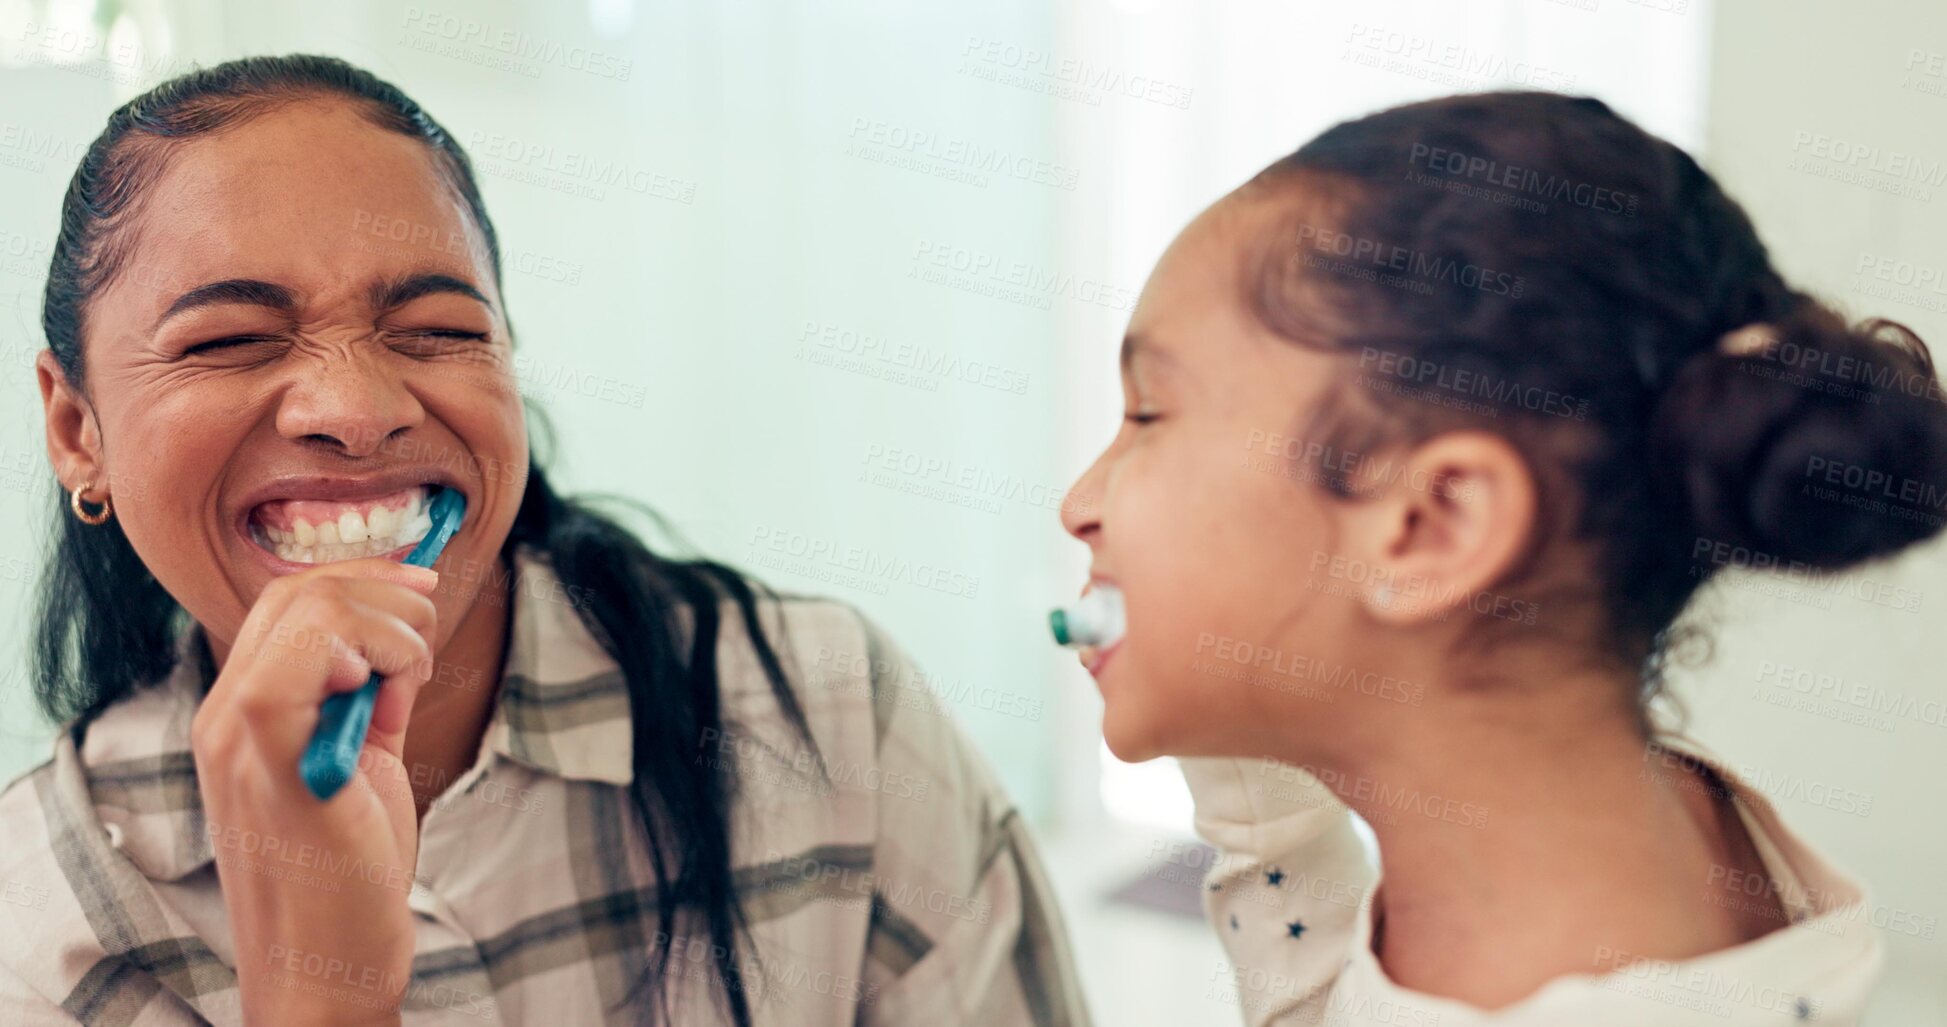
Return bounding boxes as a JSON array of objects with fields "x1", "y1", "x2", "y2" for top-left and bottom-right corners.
[{"x1": 1182, "y1": 737, "x2": 1885, "y2": 1027}]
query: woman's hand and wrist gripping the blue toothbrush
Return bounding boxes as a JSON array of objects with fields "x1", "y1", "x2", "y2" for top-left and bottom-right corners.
[{"x1": 189, "y1": 559, "x2": 438, "y2": 1025}]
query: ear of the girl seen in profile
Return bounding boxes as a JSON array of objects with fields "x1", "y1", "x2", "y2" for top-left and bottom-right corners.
[{"x1": 1340, "y1": 431, "x2": 1538, "y2": 624}]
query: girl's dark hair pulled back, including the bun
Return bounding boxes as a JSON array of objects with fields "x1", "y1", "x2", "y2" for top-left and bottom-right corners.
[{"x1": 1242, "y1": 92, "x2": 1947, "y2": 705}]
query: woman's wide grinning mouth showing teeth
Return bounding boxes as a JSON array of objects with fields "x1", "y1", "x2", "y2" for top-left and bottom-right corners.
[{"x1": 238, "y1": 477, "x2": 459, "y2": 573}]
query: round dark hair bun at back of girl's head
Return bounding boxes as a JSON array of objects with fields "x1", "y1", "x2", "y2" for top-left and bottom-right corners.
[{"x1": 1649, "y1": 300, "x2": 1947, "y2": 569}]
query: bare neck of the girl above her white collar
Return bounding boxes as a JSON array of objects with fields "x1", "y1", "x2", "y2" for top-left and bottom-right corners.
[{"x1": 1295, "y1": 676, "x2": 1762, "y2": 1008}]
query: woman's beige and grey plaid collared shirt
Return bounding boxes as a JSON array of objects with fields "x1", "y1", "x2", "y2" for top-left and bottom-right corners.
[{"x1": 0, "y1": 550, "x2": 1088, "y2": 1027}]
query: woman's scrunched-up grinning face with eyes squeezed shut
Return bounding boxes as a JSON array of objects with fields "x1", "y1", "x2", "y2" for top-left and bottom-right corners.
[{"x1": 41, "y1": 101, "x2": 528, "y2": 653}]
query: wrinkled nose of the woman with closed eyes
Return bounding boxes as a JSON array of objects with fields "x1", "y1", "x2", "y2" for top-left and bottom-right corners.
[{"x1": 276, "y1": 353, "x2": 426, "y2": 456}]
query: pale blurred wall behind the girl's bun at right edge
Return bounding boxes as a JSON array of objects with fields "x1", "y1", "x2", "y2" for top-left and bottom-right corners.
[{"x1": 1682, "y1": 0, "x2": 1947, "y2": 1023}]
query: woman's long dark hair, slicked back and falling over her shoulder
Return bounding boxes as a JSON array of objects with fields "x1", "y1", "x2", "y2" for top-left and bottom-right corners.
[{"x1": 35, "y1": 55, "x2": 816, "y2": 1025}]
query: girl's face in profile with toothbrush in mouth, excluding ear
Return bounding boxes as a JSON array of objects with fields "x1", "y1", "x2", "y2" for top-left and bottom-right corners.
[{"x1": 1063, "y1": 197, "x2": 1377, "y2": 760}]
